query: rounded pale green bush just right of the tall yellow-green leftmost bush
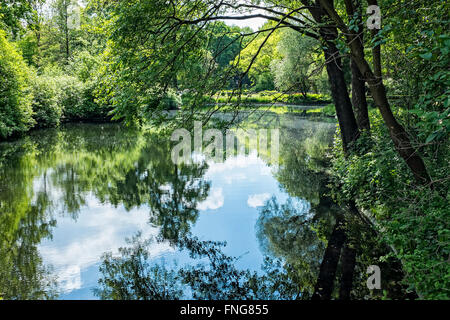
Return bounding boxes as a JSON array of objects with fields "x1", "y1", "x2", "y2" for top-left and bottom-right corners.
[{"x1": 32, "y1": 76, "x2": 62, "y2": 128}]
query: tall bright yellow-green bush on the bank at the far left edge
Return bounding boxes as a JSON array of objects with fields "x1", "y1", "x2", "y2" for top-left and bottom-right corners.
[{"x1": 0, "y1": 30, "x2": 33, "y2": 138}]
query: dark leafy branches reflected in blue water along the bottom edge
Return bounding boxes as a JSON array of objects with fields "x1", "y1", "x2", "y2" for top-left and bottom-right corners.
[{"x1": 94, "y1": 235, "x2": 302, "y2": 300}]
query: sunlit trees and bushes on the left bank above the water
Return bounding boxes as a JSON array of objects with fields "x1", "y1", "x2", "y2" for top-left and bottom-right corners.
[{"x1": 0, "y1": 0, "x2": 111, "y2": 139}]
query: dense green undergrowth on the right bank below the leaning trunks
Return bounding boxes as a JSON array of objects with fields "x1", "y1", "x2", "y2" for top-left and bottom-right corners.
[{"x1": 331, "y1": 116, "x2": 450, "y2": 299}]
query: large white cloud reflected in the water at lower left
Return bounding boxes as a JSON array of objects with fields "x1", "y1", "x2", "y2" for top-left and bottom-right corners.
[{"x1": 40, "y1": 197, "x2": 173, "y2": 293}]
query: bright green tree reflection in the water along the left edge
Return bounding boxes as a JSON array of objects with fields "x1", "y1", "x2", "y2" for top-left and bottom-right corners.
[{"x1": 0, "y1": 140, "x2": 55, "y2": 299}]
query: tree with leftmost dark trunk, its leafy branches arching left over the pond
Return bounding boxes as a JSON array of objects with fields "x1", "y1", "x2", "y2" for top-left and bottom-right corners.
[{"x1": 93, "y1": 1, "x2": 358, "y2": 149}]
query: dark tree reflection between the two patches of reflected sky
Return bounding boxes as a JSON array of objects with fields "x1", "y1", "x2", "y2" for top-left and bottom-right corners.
[{"x1": 114, "y1": 141, "x2": 210, "y2": 244}]
